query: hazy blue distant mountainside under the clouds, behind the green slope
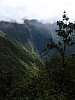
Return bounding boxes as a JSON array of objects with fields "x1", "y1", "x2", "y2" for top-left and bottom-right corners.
[{"x1": 0, "y1": 19, "x2": 54, "y2": 53}]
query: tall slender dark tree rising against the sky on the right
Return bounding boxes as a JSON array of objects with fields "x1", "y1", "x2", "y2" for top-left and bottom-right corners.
[{"x1": 43, "y1": 11, "x2": 75, "y2": 92}]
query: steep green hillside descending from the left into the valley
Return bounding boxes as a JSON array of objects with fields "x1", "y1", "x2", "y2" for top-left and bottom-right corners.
[{"x1": 0, "y1": 30, "x2": 42, "y2": 100}]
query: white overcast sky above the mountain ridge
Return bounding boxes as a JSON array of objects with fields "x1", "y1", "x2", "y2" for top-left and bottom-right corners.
[{"x1": 0, "y1": 0, "x2": 75, "y2": 22}]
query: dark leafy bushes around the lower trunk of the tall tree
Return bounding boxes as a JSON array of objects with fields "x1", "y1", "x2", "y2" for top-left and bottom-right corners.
[{"x1": 39, "y1": 55, "x2": 75, "y2": 100}]
